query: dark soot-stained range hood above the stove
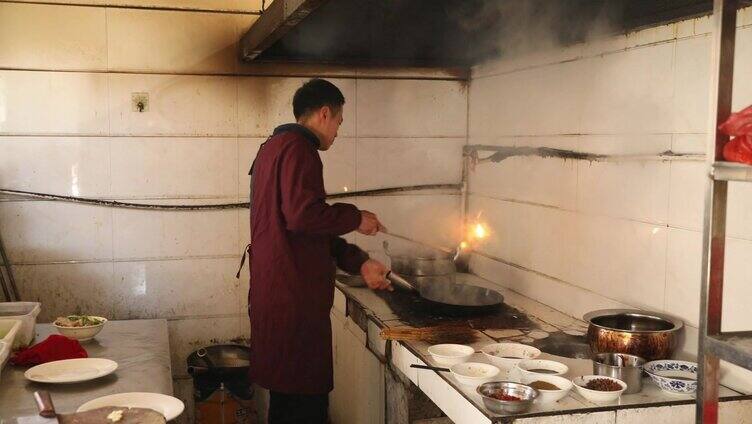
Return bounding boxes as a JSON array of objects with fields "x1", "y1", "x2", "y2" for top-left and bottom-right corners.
[{"x1": 240, "y1": 0, "x2": 749, "y2": 68}]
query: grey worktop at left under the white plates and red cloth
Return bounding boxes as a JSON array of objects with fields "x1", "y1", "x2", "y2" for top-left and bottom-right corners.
[{"x1": 0, "y1": 319, "x2": 172, "y2": 421}]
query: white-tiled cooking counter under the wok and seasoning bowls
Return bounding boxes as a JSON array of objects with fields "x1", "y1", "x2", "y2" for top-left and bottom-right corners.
[{"x1": 335, "y1": 274, "x2": 750, "y2": 423}]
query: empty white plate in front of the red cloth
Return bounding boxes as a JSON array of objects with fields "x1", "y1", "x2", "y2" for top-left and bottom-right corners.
[{"x1": 24, "y1": 358, "x2": 117, "y2": 383}]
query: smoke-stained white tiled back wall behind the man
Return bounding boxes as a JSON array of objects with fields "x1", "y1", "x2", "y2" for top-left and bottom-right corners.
[{"x1": 0, "y1": 0, "x2": 467, "y2": 416}]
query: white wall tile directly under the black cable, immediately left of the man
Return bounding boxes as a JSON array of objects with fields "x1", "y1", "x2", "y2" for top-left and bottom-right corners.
[{"x1": 113, "y1": 199, "x2": 239, "y2": 259}]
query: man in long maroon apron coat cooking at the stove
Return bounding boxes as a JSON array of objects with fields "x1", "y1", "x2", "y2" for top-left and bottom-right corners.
[{"x1": 249, "y1": 79, "x2": 391, "y2": 424}]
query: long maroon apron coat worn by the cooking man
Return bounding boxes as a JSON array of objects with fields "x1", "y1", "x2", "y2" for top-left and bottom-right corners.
[{"x1": 249, "y1": 124, "x2": 368, "y2": 394}]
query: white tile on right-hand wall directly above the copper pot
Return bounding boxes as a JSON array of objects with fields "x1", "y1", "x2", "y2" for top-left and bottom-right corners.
[{"x1": 573, "y1": 215, "x2": 668, "y2": 310}]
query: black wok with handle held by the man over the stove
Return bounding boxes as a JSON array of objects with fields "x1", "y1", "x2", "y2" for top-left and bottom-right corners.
[{"x1": 386, "y1": 271, "x2": 504, "y2": 314}]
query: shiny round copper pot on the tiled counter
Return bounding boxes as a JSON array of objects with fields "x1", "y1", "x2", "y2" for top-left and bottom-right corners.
[{"x1": 583, "y1": 309, "x2": 684, "y2": 361}]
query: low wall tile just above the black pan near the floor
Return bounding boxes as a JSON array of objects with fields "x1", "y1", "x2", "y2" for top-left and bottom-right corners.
[{"x1": 167, "y1": 315, "x2": 240, "y2": 377}]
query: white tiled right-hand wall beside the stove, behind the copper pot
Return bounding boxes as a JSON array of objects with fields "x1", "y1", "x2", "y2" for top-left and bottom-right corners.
[{"x1": 468, "y1": 8, "x2": 752, "y2": 390}]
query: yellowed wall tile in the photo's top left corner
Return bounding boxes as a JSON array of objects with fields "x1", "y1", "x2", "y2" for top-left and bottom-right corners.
[{"x1": 0, "y1": 3, "x2": 107, "y2": 70}]
